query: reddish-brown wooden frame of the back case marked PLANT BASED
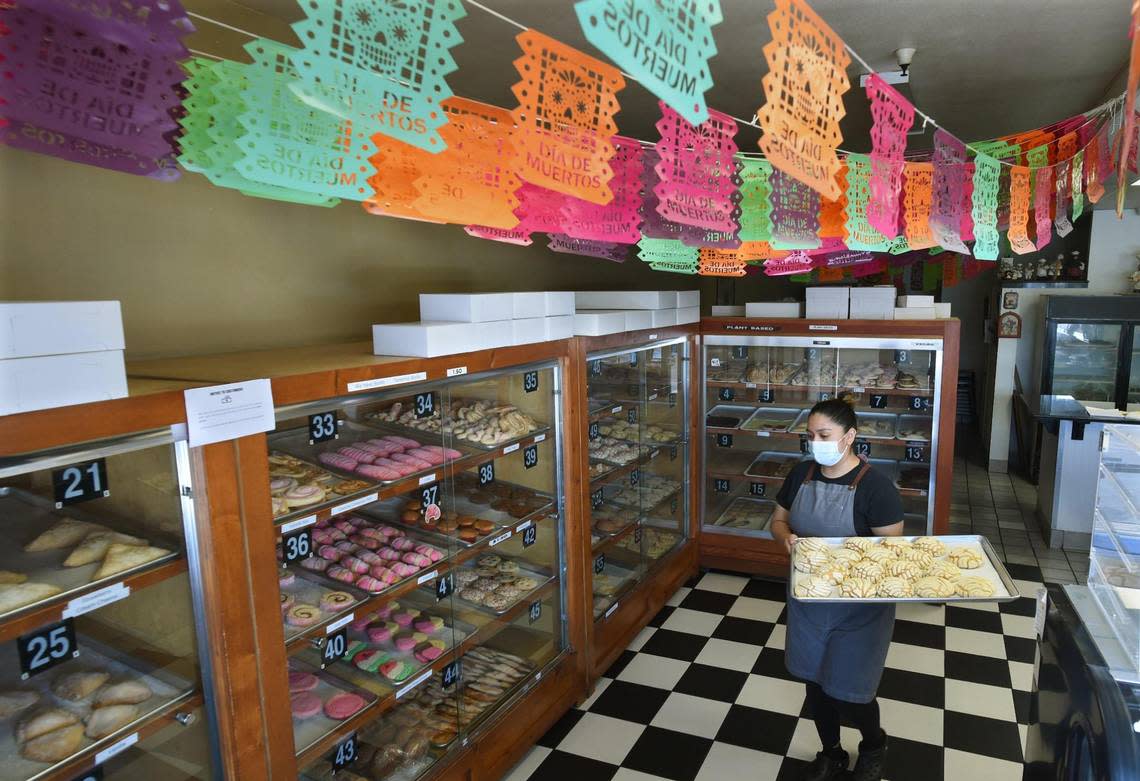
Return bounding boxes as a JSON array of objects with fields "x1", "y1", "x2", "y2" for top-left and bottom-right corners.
[{"x1": 693, "y1": 317, "x2": 961, "y2": 578}]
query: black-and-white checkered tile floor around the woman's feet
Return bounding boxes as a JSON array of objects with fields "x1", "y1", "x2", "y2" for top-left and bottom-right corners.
[{"x1": 506, "y1": 564, "x2": 1041, "y2": 781}]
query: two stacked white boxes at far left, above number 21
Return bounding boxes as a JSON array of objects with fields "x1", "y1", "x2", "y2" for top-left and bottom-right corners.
[{"x1": 0, "y1": 301, "x2": 127, "y2": 415}]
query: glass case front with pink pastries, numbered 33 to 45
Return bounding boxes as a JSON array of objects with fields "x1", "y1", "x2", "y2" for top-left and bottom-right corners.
[{"x1": 268, "y1": 361, "x2": 567, "y2": 780}]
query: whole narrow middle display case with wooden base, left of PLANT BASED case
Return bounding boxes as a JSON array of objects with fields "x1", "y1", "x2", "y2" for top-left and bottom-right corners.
[{"x1": 579, "y1": 328, "x2": 695, "y2": 676}]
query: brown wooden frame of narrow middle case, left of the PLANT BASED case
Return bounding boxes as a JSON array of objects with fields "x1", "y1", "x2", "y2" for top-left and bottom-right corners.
[{"x1": 567, "y1": 323, "x2": 702, "y2": 689}]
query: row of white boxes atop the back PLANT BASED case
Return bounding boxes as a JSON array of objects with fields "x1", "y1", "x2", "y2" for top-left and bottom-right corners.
[{"x1": 744, "y1": 285, "x2": 951, "y2": 320}]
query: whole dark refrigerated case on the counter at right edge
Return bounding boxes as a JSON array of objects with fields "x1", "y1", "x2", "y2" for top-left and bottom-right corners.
[{"x1": 1041, "y1": 295, "x2": 1140, "y2": 409}]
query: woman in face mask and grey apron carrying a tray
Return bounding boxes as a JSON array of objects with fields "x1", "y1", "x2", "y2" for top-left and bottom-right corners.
[{"x1": 772, "y1": 399, "x2": 903, "y2": 781}]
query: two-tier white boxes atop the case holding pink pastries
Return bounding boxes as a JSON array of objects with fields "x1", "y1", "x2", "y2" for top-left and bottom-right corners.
[{"x1": 372, "y1": 291, "x2": 573, "y2": 358}]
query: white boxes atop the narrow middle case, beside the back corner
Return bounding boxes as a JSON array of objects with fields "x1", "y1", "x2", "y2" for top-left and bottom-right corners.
[{"x1": 573, "y1": 291, "x2": 701, "y2": 336}]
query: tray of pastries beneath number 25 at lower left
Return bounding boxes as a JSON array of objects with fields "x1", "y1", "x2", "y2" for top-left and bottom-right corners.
[{"x1": 0, "y1": 634, "x2": 202, "y2": 781}]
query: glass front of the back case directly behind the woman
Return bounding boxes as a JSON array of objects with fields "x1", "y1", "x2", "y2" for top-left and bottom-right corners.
[{"x1": 703, "y1": 336, "x2": 942, "y2": 538}]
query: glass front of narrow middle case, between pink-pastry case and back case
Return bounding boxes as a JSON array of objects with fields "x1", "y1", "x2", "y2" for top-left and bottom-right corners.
[{"x1": 586, "y1": 337, "x2": 690, "y2": 619}]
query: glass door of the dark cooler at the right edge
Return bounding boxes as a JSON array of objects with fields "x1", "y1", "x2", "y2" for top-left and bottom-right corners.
[{"x1": 1052, "y1": 322, "x2": 1131, "y2": 402}]
